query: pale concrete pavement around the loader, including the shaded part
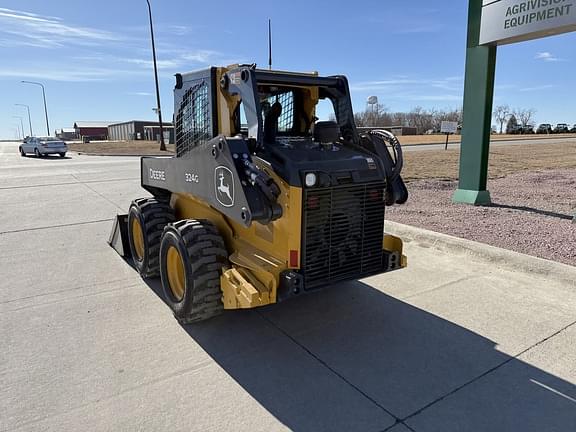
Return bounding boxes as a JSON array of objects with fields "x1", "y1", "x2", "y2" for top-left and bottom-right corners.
[{"x1": 0, "y1": 143, "x2": 576, "y2": 432}]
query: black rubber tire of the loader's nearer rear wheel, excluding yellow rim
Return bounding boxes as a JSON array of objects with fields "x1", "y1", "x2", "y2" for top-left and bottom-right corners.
[{"x1": 160, "y1": 219, "x2": 228, "y2": 324}]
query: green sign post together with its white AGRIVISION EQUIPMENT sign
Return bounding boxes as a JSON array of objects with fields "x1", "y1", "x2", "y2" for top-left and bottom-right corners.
[{"x1": 452, "y1": 0, "x2": 576, "y2": 205}]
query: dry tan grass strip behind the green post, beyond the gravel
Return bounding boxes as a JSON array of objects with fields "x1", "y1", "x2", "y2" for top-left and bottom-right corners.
[{"x1": 402, "y1": 141, "x2": 576, "y2": 181}]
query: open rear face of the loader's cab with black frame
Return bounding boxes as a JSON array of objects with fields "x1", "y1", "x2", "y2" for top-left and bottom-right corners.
[{"x1": 222, "y1": 69, "x2": 358, "y2": 150}]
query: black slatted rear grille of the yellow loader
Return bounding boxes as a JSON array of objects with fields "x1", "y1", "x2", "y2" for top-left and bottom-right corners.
[{"x1": 302, "y1": 182, "x2": 384, "y2": 289}]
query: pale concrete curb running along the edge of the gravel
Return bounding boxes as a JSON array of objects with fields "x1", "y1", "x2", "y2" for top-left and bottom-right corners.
[{"x1": 385, "y1": 221, "x2": 576, "y2": 288}]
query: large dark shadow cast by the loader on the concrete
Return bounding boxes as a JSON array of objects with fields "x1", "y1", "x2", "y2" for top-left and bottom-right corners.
[{"x1": 141, "y1": 279, "x2": 576, "y2": 432}]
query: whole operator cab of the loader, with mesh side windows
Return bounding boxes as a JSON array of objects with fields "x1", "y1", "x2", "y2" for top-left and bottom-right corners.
[{"x1": 174, "y1": 66, "x2": 359, "y2": 157}]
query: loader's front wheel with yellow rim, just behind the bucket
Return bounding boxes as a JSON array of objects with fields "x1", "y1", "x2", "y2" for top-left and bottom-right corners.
[{"x1": 128, "y1": 198, "x2": 174, "y2": 278}]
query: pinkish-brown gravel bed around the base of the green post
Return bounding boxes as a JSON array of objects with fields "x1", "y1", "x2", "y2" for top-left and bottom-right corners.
[{"x1": 386, "y1": 169, "x2": 576, "y2": 266}]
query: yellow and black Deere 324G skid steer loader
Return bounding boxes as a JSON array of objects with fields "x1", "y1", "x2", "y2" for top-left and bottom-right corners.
[{"x1": 109, "y1": 65, "x2": 408, "y2": 323}]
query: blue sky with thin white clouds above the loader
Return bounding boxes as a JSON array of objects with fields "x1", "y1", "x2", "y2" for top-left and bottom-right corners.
[{"x1": 0, "y1": 0, "x2": 576, "y2": 138}]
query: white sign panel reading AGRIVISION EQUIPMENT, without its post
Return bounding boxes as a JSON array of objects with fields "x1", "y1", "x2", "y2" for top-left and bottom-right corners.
[{"x1": 480, "y1": 0, "x2": 576, "y2": 45}]
